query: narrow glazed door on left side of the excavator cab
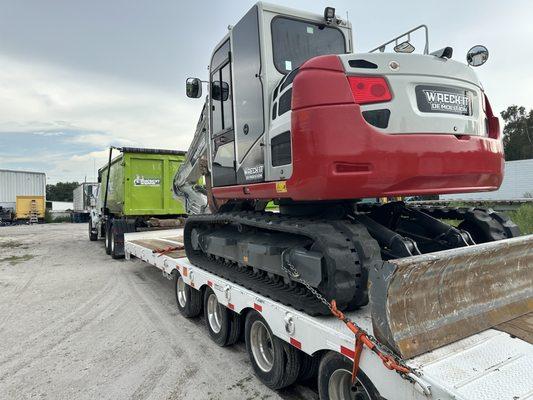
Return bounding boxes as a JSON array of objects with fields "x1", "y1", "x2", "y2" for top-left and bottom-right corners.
[{"x1": 209, "y1": 39, "x2": 237, "y2": 186}]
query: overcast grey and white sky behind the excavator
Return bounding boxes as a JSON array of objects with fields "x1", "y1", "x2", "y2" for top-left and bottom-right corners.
[{"x1": 0, "y1": 0, "x2": 533, "y2": 183}]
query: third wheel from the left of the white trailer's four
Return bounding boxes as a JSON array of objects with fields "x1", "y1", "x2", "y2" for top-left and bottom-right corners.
[{"x1": 244, "y1": 311, "x2": 301, "y2": 389}]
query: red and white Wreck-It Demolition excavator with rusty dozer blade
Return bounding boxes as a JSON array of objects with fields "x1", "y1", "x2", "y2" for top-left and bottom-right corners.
[{"x1": 173, "y1": 2, "x2": 533, "y2": 357}]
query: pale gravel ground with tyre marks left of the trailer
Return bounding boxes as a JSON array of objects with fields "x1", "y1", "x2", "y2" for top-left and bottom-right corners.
[{"x1": 0, "y1": 224, "x2": 317, "y2": 400}]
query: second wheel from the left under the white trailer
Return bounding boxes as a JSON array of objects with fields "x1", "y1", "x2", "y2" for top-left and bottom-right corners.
[{"x1": 204, "y1": 288, "x2": 241, "y2": 346}]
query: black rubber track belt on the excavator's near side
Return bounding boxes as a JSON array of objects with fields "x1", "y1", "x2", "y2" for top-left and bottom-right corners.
[{"x1": 185, "y1": 211, "x2": 379, "y2": 316}]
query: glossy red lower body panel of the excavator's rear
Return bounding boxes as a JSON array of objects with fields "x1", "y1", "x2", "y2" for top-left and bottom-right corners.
[{"x1": 213, "y1": 55, "x2": 504, "y2": 201}]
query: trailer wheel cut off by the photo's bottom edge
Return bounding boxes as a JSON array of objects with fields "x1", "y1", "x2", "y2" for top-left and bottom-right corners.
[{"x1": 318, "y1": 351, "x2": 381, "y2": 400}]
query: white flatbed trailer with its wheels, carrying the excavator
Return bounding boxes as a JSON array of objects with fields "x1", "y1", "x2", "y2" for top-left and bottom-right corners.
[{"x1": 125, "y1": 229, "x2": 533, "y2": 400}]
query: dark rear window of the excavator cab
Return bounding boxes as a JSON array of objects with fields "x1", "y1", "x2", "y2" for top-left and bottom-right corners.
[{"x1": 272, "y1": 17, "x2": 346, "y2": 74}]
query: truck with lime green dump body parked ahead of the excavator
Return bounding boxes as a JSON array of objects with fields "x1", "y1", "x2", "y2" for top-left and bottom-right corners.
[{"x1": 89, "y1": 147, "x2": 185, "y2": 258}]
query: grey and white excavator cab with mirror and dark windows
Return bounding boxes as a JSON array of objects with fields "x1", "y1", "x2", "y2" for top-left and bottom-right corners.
[{"x1": 187, "y1": 3, "x2": 352, "y2": 187}]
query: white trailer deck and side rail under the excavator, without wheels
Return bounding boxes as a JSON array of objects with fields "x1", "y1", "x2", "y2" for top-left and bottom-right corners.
[{"x1": 125, "y1": 229, "x2": 533, "y2": 400}]
